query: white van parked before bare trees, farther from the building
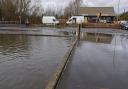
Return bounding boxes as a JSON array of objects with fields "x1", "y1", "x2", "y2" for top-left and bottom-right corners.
[{"x1": 42, "y1": 16, "x2": 59, "y2": 25}]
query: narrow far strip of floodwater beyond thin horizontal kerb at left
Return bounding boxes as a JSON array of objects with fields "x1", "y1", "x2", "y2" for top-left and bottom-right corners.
[{"x1": 0, "y1": 27, "x2": 76, "y2": 36}]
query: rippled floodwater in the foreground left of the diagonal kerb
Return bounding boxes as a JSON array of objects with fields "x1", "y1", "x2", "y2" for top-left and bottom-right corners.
[{"x1": 0, "y1": 35, "x2": 72, "y2": 89}]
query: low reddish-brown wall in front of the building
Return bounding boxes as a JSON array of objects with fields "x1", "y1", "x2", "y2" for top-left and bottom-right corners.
[{"x1": 82, "y1": 23, "x2": 120, "y2": 29}]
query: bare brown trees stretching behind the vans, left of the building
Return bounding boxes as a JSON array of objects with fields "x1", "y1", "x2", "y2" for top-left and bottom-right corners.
[{"x1": 0, "y1": 0, "x2": 82, "y2": 24}]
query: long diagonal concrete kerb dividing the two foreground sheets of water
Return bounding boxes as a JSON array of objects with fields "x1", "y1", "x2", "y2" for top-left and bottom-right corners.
[{"x1": 45, "y1": 39, "x2": 78, "y2": 89}]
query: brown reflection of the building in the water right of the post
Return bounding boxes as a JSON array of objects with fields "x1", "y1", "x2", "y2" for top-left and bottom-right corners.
[{"x1": 81, "y1": 32, "x2": 113, "y2": 44}]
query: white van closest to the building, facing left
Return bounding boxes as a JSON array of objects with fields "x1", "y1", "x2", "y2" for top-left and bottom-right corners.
[{"x1": 66, "y1": 16, "x2": 85, "y2": 24}]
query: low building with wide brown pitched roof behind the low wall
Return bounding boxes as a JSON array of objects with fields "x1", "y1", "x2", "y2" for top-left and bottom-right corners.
[{"x1": 79, "y1": 7, "x2": 116, "y2": 23}]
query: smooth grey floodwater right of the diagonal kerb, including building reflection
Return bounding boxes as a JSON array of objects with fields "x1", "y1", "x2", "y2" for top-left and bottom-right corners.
[{"x1": 56, "y1": 33, "x2": 128, "y2": 89}]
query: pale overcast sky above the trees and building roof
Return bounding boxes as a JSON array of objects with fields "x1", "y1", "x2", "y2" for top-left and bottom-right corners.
[{"x1": 42, "y1": 0, "x2": 128, "y2": 12}]
